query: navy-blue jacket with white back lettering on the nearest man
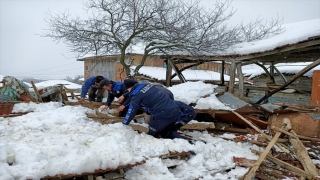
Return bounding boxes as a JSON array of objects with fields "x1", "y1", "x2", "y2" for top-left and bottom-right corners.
[{"x1": 122, "y1": 83, "x2": 178, "y2": 124}]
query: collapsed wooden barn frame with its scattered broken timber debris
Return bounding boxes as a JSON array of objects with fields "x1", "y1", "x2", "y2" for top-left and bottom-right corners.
[{"x1": 1, "y1": 18, "x2": 320, "y2": 179}]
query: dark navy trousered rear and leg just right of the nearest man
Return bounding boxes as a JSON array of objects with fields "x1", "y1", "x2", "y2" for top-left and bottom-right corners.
[{"x1": 160, "y1": 101, "x2": 197, "y2": 139}]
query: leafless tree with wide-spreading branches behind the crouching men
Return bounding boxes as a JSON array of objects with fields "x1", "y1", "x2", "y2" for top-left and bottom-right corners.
[{"x1": 44, "y1": 0, "x2": 279, "y2": 77}]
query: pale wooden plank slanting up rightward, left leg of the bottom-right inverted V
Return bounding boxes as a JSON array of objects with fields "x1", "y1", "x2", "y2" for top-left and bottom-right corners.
[{"x1": 240, "y1": 132, "x2": 281, "y2": 180}]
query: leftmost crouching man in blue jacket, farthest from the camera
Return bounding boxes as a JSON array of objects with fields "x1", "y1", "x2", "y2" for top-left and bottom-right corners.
[{"x1": 78, "y1": 76, "x2": 109, "y2": 103}]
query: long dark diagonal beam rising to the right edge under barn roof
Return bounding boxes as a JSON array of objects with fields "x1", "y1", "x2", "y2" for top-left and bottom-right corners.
[{"x1": 255, "y1": 58, "x2": 320, "y2": 104}]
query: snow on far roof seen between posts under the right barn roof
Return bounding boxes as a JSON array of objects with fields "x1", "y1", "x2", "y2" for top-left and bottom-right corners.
[{"x1": 242, "y1": 62, "x2": 320, "y2": 79}]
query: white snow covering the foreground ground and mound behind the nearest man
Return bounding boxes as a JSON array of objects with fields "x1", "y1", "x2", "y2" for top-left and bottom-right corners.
[{"x1": 0, "y1": 81, "x2": 262, "y2": 180}]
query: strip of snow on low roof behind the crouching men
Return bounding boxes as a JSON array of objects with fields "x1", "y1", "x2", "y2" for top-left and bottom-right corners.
[{"x1": 131, "y1": 66, "x2": 238, "y2": 81}]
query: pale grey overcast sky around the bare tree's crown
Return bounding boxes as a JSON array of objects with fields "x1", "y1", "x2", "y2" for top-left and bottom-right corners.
[{"x1": 0, "y1": 0, "x2": 320, "y2": 79}]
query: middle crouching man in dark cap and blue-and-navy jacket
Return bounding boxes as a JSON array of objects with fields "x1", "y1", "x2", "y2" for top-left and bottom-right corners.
[{"x1": 100, "y1": 80, "x2": 129, "y2": 117}]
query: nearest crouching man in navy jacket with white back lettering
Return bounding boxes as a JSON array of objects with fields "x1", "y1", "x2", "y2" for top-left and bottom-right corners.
[{"x1": 122, "y1": 79, "x2": 180, "y2": 137}]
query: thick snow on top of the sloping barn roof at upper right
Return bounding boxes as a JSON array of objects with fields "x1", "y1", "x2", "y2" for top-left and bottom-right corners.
[{"x1": 222, "y1": 19, "x2": 320, "y2": 55}]
